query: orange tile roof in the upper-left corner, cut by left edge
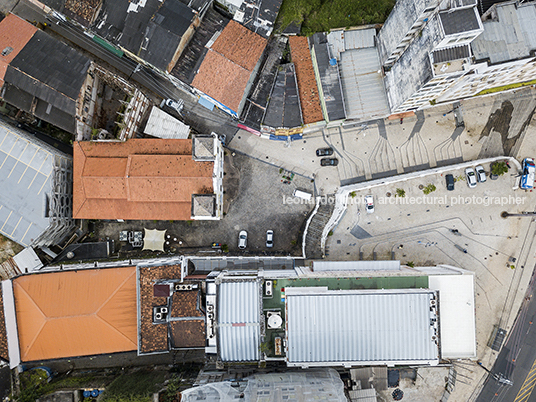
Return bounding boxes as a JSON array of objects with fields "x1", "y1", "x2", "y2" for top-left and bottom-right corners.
[{"x1": 0, "y1": 14, "x2": 37, "y2": 88}]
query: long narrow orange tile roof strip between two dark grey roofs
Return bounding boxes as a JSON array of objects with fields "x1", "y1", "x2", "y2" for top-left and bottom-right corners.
[{"x1": 288, "y1": 36, "x2": 324, "y2": 124}]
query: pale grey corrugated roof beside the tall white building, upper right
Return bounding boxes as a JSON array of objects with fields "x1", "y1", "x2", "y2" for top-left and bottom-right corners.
[{"x1": 340, "y1": 47, "x2": 389, "y2": 119}]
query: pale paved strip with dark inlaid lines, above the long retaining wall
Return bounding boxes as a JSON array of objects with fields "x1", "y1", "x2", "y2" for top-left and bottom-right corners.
[{"x1": 229, "y1": 88, "x2": 536, "y2": 195}]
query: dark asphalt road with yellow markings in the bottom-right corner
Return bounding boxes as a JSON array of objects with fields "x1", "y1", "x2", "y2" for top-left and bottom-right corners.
[{"x1": 477, "y1": 267, "x2": 536, "y2": 402}]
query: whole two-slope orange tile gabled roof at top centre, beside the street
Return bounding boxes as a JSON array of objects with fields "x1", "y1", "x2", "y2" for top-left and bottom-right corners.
[{"x1": 192, "y1": 20, "x2": 267, "y2": 112}]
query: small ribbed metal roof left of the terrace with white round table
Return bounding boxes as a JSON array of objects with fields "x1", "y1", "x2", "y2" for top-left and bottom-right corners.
[{"x1": 217, "y1": 281, "x2": 260, "y2": 361}]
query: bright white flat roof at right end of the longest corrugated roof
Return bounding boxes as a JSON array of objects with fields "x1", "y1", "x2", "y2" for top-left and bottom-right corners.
[{"x1": 428, "y1": 274, "x2": 476, "y2": 359}]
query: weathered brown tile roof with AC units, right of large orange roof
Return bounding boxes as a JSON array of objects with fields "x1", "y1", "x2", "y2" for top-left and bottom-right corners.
[{"x1": 138, "y1": 265, "x2": 181, "y2": 353}]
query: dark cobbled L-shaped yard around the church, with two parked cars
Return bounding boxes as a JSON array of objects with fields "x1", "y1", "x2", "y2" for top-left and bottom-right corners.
[{"x1": 93, "y1": 151, "x2": 313, "y2": 256}]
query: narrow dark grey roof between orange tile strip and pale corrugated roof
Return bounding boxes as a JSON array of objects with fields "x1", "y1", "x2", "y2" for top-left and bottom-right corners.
[{"x1": 309, "y1": 32, "x2": 346, "y2": 121}]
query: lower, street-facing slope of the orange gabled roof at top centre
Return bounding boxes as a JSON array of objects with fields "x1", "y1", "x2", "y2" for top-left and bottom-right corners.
[{"x1": 192, "y1": 50, "x2": 251, "y2": 112}]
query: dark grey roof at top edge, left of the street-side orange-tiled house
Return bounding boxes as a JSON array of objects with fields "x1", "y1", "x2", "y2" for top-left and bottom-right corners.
[{"x1": 139, "y1": 0, "x2": 195, "y2": 70}]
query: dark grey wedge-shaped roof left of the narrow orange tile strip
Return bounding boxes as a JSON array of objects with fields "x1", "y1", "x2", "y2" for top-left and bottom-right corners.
[{"x1": 263, "y1": 63, "x2": 303, "y2": 128}]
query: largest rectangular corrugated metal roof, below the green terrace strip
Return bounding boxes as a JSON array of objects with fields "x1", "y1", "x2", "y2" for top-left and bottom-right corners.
[{"x1": 285, "y1": 287, "x2": 439, "y2": 366}]
